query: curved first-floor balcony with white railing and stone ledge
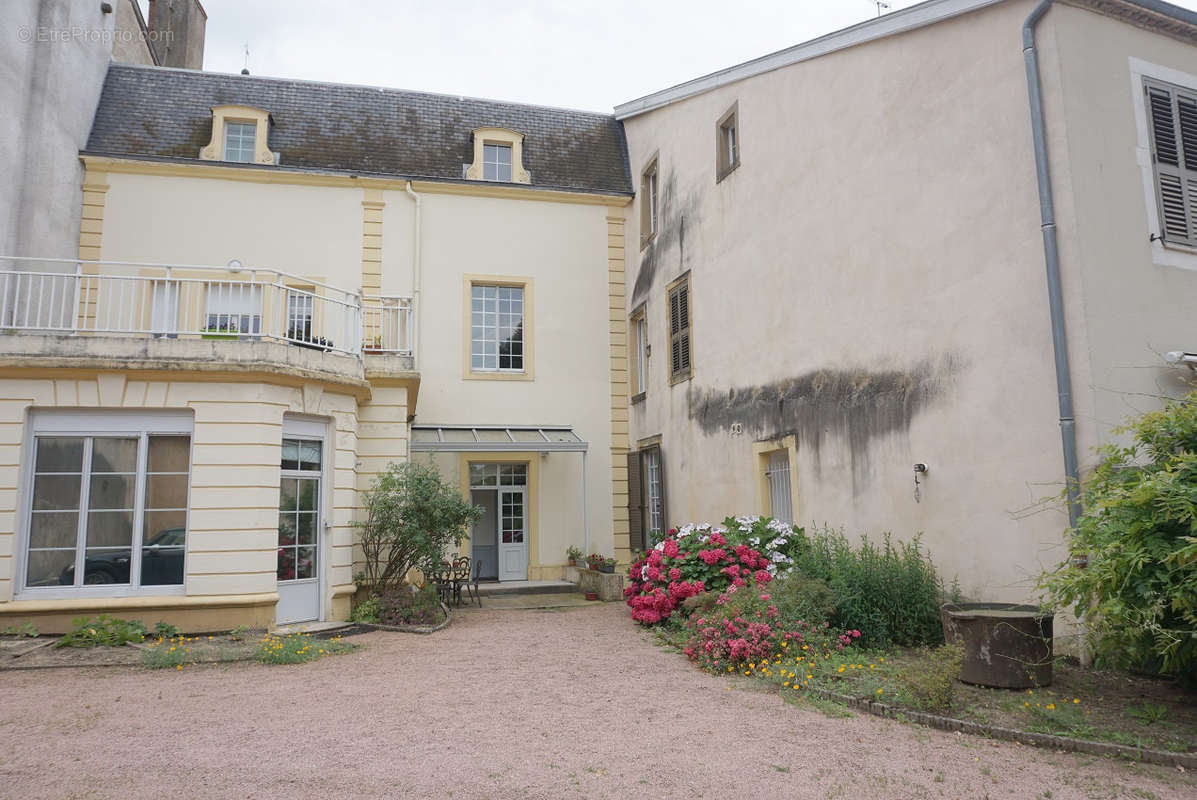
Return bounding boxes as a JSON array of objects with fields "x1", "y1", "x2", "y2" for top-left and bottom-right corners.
[{"x1": 0, "y1": 256, "x2": 413, "y2": 377}]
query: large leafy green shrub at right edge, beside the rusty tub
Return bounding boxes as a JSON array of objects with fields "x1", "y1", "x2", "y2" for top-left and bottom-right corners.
[{"x1": 1040, "y1": 392, "x2": 1197, "y2": 685}]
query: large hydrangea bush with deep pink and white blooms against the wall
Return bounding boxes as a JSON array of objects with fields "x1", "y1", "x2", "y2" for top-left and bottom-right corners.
[{"x1": 624, "y1": 516, "x2": 802, "y2": 625}]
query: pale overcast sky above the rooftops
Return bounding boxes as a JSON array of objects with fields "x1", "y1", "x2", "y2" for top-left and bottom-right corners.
[{"x1": 163, "y1": 0, "x2": 1197, "y2": 111}]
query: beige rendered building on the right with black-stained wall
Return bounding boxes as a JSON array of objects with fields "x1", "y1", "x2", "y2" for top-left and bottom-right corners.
[{"x1": 616, "y1": 0, "x2": 1197, "y2": 600}]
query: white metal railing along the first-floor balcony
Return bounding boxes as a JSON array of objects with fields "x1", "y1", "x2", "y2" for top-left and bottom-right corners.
[{"x1": 0, "y1": 256, "x2": 412, "y2": 356}]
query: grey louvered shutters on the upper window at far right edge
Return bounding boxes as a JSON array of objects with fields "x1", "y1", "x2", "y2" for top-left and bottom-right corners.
[{"x1": 1144, "y1": 81, "x2": 1197, "y2": 246}]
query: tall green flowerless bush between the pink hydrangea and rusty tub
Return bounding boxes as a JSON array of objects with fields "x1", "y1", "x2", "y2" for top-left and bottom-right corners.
[{"x1": 790, "y1": 527, "x2": 944, "y2": 648}]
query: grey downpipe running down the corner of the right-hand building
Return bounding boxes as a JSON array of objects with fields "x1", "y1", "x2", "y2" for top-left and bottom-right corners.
[{"x1": 1022, "y1": 0, "x2": 1081, "y2": 528}]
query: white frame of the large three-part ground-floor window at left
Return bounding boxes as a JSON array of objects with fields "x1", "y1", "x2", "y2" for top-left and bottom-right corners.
[{"x1": 14, "y1": 408, "x2": 195, "y2": 600}]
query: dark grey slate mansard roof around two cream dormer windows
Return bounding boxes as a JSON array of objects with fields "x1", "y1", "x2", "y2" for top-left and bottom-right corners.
[{"x1": 84, "y1": 62, "x2": 632, "y2": 194}]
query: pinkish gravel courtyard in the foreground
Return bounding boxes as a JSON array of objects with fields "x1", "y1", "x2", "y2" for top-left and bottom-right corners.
[{"x1": 0, "y1": 604, "x2": 1197, "y2": 800}]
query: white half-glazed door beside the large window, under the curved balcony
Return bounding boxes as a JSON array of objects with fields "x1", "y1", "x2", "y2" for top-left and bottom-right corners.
[{"x1": 275, "y1": 438, "x2": 324, "y2": 625}]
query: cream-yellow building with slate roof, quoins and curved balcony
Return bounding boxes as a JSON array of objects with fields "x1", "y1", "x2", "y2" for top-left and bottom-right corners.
[{"x1": 0, "y1": 65, "x2": 631, "y2": 631}]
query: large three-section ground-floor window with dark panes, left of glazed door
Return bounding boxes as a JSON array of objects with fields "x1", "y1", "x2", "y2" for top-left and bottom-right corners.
[{"x1": 25, "y1": 434, "x2": 190, "y2": 588}]
